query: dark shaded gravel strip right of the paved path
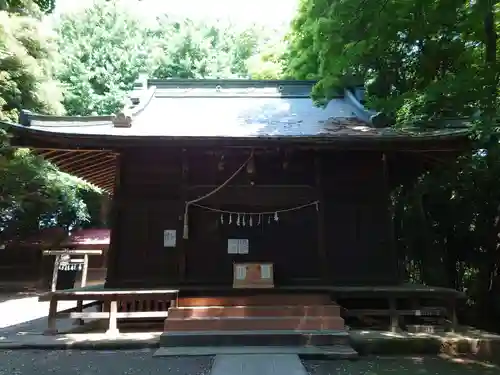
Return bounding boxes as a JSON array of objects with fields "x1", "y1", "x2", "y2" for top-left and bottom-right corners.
[{"x1": 303, "y1": 357, "x2": 500, "y2": 375}]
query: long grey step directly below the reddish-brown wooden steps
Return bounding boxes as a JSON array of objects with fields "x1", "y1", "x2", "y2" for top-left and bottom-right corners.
[{"x1": 160, "y1": 330, "x2": 349, "y2": 347}]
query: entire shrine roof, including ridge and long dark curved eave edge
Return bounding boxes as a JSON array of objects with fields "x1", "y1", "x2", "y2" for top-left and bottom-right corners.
[{"x1": 2, "y1": 79, "x2": 468, "y2": 149}]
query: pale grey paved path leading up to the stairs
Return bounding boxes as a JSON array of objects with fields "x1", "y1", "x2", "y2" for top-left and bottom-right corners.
[{"x1": 210, "y1": 354, "x2": 308, "y2": 375}]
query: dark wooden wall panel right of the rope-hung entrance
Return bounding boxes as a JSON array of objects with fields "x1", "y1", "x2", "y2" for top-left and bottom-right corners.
[{"x1": 324, "y1": 152, "x2": 398, "y2": 285}]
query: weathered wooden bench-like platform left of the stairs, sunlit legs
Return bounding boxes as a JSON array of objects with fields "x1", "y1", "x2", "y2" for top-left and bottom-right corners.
[{"x1": 38, "y1": 285, "x2": 178, "y2": 335}]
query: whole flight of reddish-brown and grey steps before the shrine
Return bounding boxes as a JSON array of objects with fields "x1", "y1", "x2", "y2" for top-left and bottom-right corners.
[{"x1": 156, "y1": 293, "x2": 357, "y2": 358}]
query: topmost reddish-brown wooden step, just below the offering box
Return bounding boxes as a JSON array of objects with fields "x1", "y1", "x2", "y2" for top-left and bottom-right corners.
[{"x1": 177, "y1": 294, "x2": 331, "y2": 307}]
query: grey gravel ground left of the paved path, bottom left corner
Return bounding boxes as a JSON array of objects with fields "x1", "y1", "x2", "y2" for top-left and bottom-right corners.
[{"x1": 0, "y1": 350, "x2": 213, "y2": 375}]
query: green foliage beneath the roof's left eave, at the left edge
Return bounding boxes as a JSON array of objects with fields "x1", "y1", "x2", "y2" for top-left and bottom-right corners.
[{"x1": 0, "y1": 145, "x2": 95, "y2": 243}]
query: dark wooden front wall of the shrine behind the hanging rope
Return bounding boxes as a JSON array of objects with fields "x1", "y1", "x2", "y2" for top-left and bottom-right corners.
[{"x1": 107, "y1": 147, "x2": 397, "y2": 287}]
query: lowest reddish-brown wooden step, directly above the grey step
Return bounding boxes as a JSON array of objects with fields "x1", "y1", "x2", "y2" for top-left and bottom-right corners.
[{"x1": 164, "y1": 316, "x2": 345, "y2": 332}]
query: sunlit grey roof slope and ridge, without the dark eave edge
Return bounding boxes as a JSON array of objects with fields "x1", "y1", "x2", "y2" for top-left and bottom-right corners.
[{"x1": 12, "y1": 80, "x2": 394, "y2": 138}]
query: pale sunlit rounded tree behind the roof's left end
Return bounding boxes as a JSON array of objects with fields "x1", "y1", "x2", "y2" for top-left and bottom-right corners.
[{"x1": 51, "y1": 0, "x2": 153, "y2": 115}]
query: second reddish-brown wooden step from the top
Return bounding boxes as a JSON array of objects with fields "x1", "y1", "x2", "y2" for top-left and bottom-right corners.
[{"x1": 168, "y1": 304, "x2": 340, "y2": 319}]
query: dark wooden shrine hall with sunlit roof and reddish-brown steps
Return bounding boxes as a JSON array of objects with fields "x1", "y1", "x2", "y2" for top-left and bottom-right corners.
[{"x1": 1, "y1": 79, "x2": 468, "y2": 352}]
